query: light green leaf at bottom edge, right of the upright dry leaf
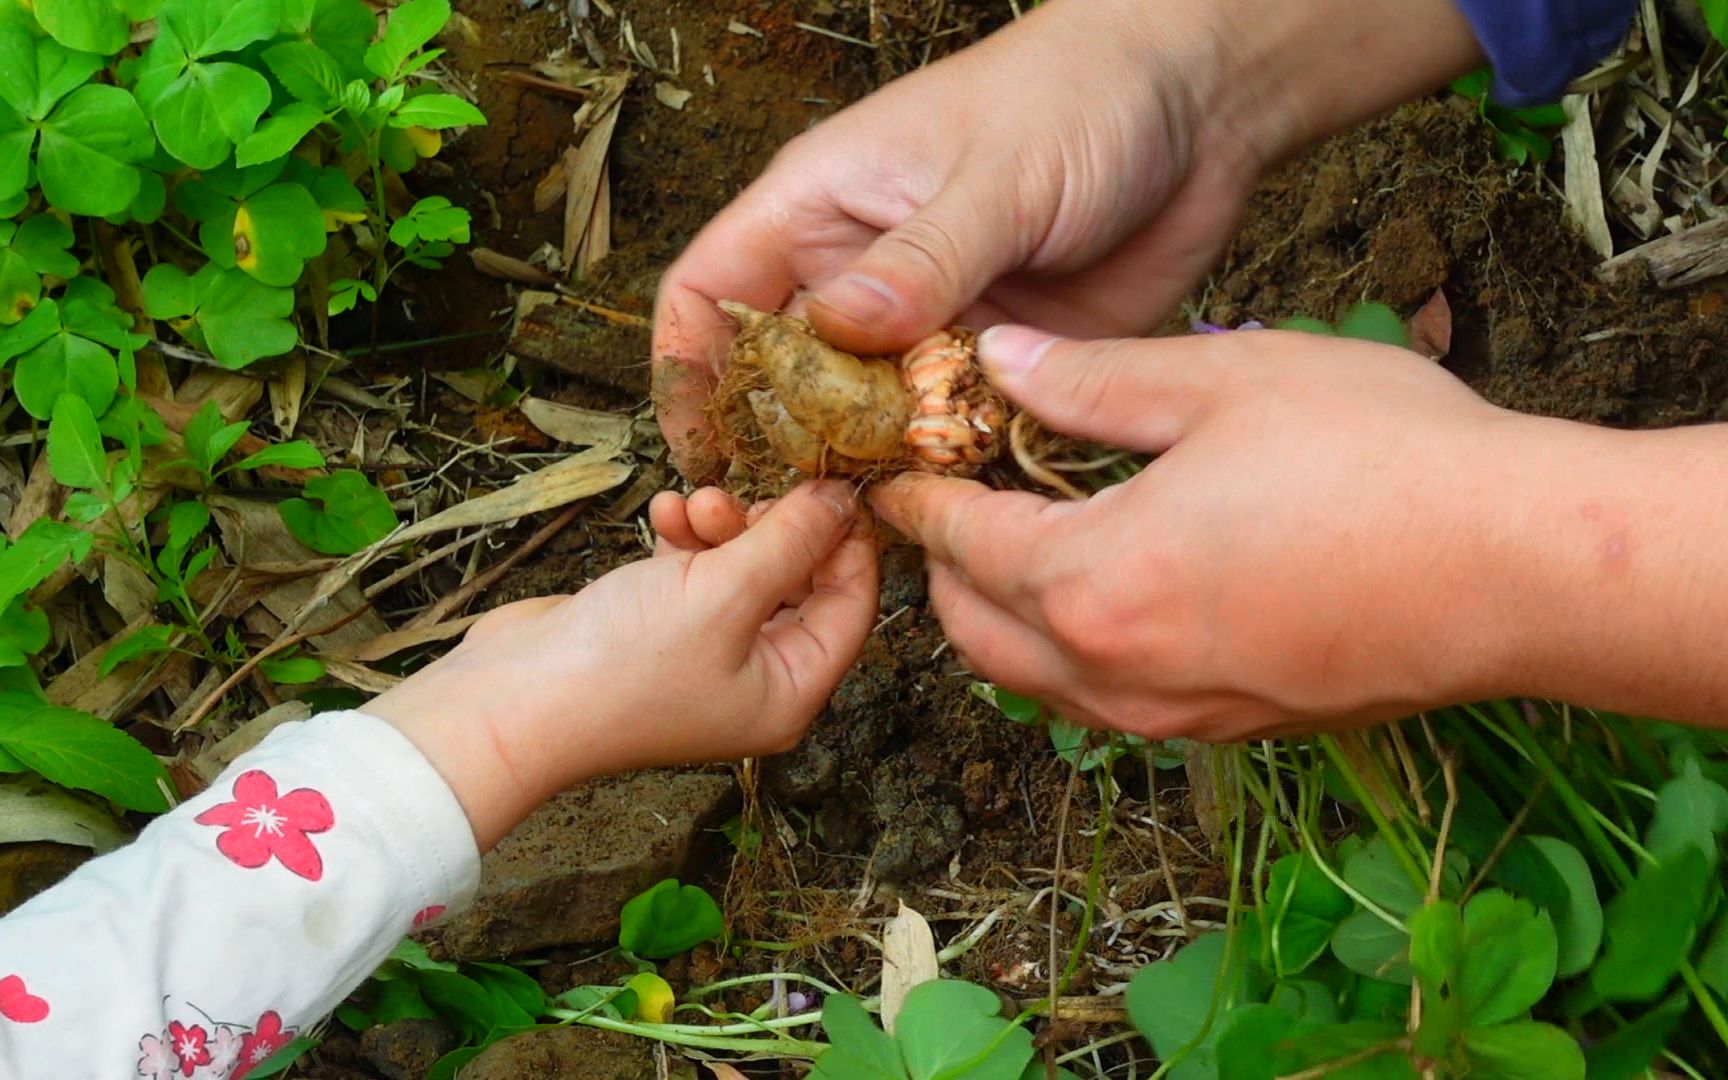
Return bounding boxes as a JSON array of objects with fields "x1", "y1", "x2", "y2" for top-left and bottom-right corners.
[{"x1": 893, "y1": 978, "x2": 1032, "y2": 1080}]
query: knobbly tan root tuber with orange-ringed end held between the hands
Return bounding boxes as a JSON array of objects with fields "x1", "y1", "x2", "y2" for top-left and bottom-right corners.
[{"x1": 710, "y1": 301, "x2": 1011, "y2": 477}]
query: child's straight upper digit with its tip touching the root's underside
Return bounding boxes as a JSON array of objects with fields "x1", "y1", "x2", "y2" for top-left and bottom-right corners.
[{"x1": 698, "y1": 480, "x2": 857, "y2": 626}]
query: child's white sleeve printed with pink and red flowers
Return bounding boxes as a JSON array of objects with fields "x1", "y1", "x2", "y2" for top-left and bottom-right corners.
[{"x1": 0, "y1": 712, "x2": 480, "y2": 1080}]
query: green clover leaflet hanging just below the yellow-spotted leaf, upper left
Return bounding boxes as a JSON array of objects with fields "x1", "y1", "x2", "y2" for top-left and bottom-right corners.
[{"x1": 143, "y1": 263, "x2": 299, "y2": 370}]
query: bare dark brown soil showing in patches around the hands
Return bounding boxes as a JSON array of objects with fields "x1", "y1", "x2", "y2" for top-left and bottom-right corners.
[{"x1": 297, "y1": 0, "x2": 1728, "y2": 1077}]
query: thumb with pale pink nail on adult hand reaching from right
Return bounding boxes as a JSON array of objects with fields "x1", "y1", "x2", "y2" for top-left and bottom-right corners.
[{"x1": 978, "y1": 325, "x2": 1217, "y2": 453}]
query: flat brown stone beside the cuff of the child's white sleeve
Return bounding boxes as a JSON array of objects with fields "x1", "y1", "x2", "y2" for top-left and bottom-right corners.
[{"x1": 427, "y1": 771, "x2": 740, "y2": 960}]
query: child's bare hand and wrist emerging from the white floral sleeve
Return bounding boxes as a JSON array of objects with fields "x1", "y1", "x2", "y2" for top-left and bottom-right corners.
[{"x1": 368, "y1": 482, "x2": 878, "y2": 850}]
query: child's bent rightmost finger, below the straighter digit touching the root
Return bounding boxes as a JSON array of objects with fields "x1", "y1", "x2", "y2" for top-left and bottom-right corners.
[{"x1": 762, "y1": 529, "x2": 880, "y2": 712}]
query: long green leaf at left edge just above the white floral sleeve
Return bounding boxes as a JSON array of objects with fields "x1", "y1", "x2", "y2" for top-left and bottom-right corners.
[{"x1": 0, "y1": 691, "x2": 168, "y2": 814}]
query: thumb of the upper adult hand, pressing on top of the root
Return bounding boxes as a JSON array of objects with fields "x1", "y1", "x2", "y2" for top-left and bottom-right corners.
[{"x1": 809, "y1": 178, "x2": 1026, "y2": 354}]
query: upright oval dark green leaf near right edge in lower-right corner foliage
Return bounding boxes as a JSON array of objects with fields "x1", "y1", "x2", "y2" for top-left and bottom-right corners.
[{"x1": 1590, "y1": 845, "x2": 1711, "y2": 1001}]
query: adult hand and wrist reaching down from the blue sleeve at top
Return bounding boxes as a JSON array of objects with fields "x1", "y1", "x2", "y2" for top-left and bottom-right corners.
[{"x1": 653, "y1": 0, "x2": 1479, "y2": 479}]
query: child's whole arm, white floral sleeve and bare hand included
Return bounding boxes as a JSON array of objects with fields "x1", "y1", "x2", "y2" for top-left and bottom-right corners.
[{"x1": 0, "y1": 486, "x2": 876, "y2": 1080}]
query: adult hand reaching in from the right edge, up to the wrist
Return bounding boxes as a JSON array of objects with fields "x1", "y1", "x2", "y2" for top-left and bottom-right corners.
[{"x1": 873, "y1": 327, "x2": 1548, "y2": 741}]
